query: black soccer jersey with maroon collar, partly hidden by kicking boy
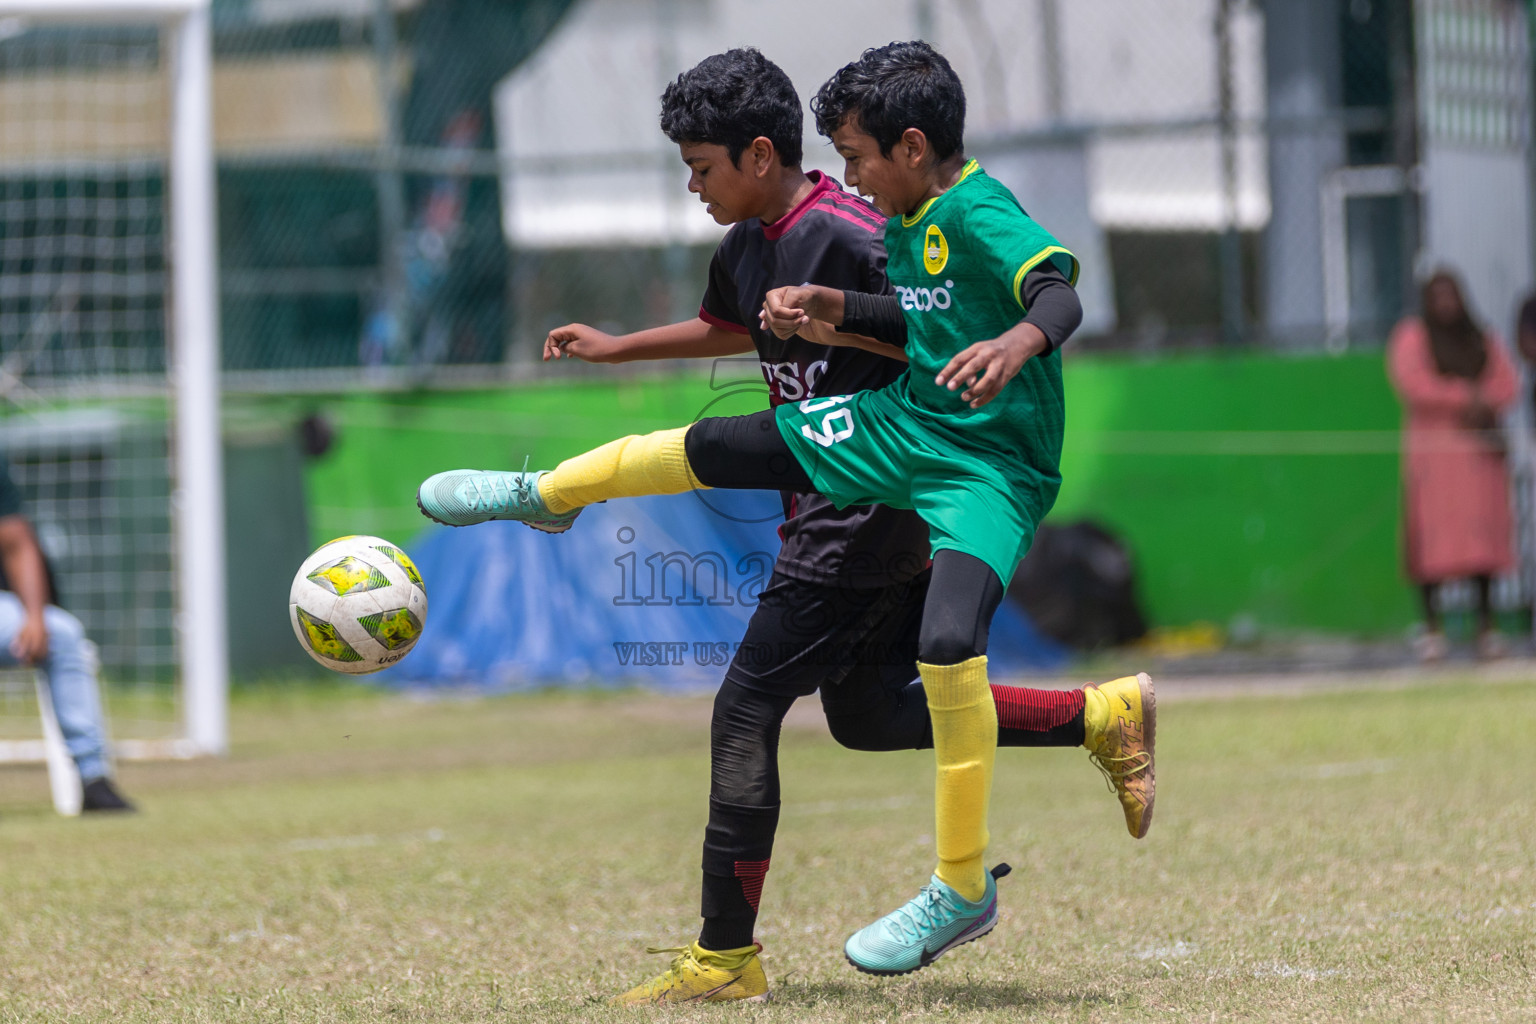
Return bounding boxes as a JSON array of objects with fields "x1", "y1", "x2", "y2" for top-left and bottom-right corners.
[{"x1": 699, "y1": 170, "x2": 928, "y2": 586}]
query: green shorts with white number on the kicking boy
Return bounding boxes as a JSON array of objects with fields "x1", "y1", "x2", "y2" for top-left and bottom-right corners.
[{"x1": 774, "y1": 388, "x2": 1055, "y2": 586}]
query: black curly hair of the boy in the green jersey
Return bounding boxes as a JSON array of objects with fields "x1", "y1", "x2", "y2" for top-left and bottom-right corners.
[{"x1": 811, "y1": 40, "x2": 965, "y2": 160}]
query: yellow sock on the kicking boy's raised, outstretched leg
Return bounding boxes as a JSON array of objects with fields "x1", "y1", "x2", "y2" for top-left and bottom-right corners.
[{"x1": 539, "y1": 427, "x2": 703, "y2": 513}]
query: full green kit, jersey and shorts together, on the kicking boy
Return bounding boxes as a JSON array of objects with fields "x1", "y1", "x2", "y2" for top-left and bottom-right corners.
[{"x1": 774, "y1": 160, "x2": 1077, "y2": 585}]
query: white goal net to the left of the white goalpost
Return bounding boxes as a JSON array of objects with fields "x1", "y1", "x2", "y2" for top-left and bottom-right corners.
[{"x1": 0, "y1": 18, "x2": 180, "y2": 752}]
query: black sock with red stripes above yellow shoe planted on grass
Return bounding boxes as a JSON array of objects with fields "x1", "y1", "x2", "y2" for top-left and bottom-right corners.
[{"x1": 699, "y1": 797, "x2": 779, "y2": 950}]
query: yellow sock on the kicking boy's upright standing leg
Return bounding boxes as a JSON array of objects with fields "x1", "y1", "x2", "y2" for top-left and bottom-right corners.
[{"x1": 917, "y1": 656, "x2": 997, "y2": 901}]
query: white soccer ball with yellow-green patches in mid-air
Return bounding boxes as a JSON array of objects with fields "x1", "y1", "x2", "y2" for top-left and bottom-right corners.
[{"x1": 289, "y1": 536, "x2": 427, "y2": 676}]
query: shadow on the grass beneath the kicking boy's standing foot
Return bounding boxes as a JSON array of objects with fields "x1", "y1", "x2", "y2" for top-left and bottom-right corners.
[{"x1": 773, "y1": 979, "x2": 1124, "y2": 1012}]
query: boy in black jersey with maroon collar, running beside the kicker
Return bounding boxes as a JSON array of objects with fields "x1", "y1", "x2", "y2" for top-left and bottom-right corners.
[{"x1": 544, "y1": 49, "x2": 1118, "y2": 1003}]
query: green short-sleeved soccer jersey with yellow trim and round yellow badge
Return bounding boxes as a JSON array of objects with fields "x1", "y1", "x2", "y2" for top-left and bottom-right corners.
[{"x1": 885, "y1": 160, "x2": 1078, "y2": 497}]
